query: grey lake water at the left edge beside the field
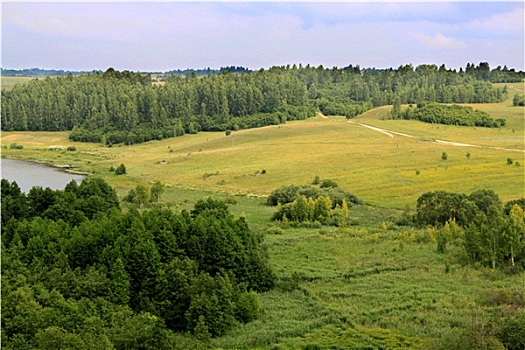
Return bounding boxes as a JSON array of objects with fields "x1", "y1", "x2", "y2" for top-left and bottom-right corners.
[{"x1": 1, "y1": 159, "x2": 86, "y2": 193}]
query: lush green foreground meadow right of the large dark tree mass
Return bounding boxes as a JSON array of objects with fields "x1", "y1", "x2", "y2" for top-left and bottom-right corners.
[{"x1": 205, "y1": 225, "x2": 525, "y2": 349}]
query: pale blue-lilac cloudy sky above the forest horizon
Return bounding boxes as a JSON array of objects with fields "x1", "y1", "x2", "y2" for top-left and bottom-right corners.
[{"x1": 1, "y1": 0, "x2": 525, "y2": 72}]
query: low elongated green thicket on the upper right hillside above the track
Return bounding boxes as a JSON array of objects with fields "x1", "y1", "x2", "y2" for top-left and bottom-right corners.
[{"x1": 390, "y1": 103, "x2": 505, "y2": 128}]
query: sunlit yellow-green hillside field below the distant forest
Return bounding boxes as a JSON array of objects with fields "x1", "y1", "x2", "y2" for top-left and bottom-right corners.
[{"x1": 2, "y1": 89, "x2": 525, "y2": 208}]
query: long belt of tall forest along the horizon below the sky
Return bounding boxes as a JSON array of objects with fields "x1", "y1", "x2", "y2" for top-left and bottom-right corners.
[{"x1": 1, "y1": 62, "x2": 523, "y2": 145}]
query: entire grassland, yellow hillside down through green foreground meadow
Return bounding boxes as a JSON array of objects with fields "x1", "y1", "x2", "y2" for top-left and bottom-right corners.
[{"x1": 2, "y1": 84, "x2": 525, "y2": 349}]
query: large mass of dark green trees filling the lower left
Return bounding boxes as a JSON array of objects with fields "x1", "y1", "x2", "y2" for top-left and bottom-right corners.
[{"x1": 1, "y1": 178, "x2": 275, "y2": 349}]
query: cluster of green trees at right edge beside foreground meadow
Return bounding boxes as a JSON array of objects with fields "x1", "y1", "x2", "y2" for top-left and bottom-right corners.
[{"x1": 413, "y1": 190, "x2": 525, "y2": 271}]
